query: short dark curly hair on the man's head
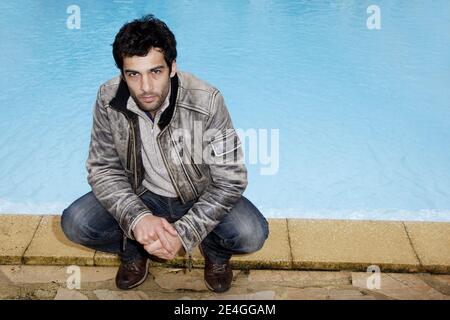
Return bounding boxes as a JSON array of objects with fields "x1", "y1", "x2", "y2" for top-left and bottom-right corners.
[{"x1": 112, "y1": 14, "x2": 177, "y2": 72}]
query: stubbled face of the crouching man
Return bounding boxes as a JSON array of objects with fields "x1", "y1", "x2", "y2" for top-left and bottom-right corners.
[{"x1": 123, "y1": 48, "x2": 176, "y2": 116}]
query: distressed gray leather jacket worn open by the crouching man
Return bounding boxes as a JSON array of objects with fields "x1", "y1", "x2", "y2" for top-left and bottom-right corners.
[{"x1": 86, "y1": 72, "x2": 247, "y2": 262}]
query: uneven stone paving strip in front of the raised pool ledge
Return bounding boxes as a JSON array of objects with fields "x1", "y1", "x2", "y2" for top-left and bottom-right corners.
[{"x1": 0, "y1": 265, "x2": 450, "y2": 300}]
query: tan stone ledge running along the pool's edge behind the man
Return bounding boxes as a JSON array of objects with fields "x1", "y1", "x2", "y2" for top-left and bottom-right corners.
[{"x1": 0, "y1": 215, "x2": 450, "y2": 274}]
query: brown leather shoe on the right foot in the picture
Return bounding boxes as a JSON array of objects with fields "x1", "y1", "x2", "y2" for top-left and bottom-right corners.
[{"x1": 199, "y1": 245, "x2": 233, "y2": 293}]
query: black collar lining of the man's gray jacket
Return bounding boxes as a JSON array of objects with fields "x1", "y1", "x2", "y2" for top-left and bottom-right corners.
[{"x1": 109, "y1": 74, "x2": 178, "y2": 130}]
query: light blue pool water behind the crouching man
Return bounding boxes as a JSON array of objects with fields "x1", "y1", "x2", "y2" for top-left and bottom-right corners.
[{"x1": 0, "y1": 0, "x2": 450, "y2": 221}]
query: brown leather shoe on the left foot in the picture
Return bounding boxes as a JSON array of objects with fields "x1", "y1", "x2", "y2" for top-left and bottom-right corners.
[{"x1": 116, "y1": 258, "x2": 150, "y2": 290}]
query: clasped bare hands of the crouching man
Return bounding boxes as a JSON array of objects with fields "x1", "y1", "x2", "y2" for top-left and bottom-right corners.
[{"x1": 133, "y1": 215, "x2": 182, "y2": 260}]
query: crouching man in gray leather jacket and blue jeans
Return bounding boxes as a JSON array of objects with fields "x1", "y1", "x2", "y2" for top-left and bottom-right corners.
[{"x1": 61, "y1": 15, "x2": 269, "y2": 292}]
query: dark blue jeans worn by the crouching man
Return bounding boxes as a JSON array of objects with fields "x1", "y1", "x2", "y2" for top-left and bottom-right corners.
[{"x1": 61, "y1": 191, "x2": 269, "y2": 263}]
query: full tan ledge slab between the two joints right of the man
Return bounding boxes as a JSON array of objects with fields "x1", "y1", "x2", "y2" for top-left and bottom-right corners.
[{"x1": 288, "y1": 219, "x2": 421, "y2": 272}]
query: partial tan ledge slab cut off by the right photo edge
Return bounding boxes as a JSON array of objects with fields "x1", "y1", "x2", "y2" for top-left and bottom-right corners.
[{"x1": 405, "y1": 222, "x2": 450, "y2": 274}]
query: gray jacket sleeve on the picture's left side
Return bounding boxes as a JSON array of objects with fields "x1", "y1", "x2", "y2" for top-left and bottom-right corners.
[{"x1": 86, "y1": 87, "x2": 151, "y2": 239}]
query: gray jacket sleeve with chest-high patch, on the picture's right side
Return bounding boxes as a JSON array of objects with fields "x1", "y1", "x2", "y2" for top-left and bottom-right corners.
[{"x1": 174, "y1": 91, "x2": 247, "y2": 252}]
